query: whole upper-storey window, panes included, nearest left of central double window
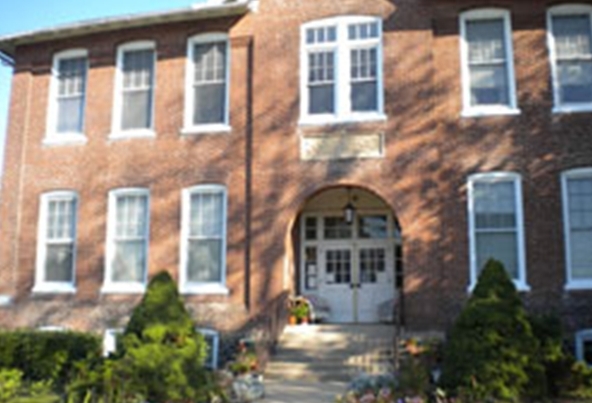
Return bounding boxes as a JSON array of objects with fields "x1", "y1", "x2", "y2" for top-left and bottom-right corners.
[{"x1": 183, "y1": 33, "x2": 230, "y2": 134}]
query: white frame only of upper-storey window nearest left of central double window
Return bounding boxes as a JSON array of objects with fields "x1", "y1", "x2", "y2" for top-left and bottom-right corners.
[{"x1": 181, "y1": 32, "x2": 232, "y2": 135}]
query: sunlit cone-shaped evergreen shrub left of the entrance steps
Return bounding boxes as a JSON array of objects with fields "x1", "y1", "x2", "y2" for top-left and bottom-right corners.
[{"x1": 117, "y1": 272, "x2": 212, "y2": 402}]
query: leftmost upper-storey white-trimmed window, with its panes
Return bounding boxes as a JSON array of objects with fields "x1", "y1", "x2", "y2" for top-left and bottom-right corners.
[{"x1": 44, "y1": 49, "x2": 88, "y2": 144}]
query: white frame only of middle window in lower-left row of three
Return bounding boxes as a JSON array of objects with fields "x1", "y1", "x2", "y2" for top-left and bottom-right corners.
[{"x1": 101, "y1": 188, "x2": 150, "y2": 294}]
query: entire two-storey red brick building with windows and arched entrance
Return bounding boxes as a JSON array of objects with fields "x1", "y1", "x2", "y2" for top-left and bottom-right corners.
[{"x1": 0, "y1": 0, "x2": 592, "y2": 361}]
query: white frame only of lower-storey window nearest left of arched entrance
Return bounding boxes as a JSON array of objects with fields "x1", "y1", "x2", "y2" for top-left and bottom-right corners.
[{"x1": 179, "y1": 184, "x2": 229, "y2": 295}]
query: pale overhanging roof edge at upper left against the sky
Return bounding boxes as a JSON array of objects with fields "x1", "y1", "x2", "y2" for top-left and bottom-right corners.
[{"x1": 0, "y1": 0, "x2": 252, "y2": 59}]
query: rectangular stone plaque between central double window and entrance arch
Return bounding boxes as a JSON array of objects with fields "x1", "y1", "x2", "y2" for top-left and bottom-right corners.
[{"x1": 300, "y1": 133, "x2": 384, "y2": 161}]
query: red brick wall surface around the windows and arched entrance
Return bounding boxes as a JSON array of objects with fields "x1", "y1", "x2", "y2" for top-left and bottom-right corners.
[{"x1": 0, "y1": 0, "x2": 592, "y2": 330}]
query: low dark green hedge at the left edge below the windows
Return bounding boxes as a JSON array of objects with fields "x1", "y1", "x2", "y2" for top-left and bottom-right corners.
[{"x1": 0, "y1": 330, "x2": 101, "y2": 389}]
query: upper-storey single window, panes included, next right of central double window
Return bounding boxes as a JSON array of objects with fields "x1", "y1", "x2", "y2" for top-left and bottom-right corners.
[{"x1": 460, "y1": 9, "x2": 519, "y2": 116}]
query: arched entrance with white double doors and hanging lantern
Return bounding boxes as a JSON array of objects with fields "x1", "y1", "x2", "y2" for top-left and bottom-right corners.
[{"x1": 297, "y1": 187, "x2": 403, "y2": 323}]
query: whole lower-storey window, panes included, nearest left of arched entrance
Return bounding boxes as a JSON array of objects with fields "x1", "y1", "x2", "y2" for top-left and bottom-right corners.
[{"x1": 180, "y1": 185, "x2": 228, "y2": 294}]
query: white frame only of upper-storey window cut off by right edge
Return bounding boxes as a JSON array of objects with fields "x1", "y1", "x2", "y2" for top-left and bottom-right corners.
[{"x1": 547, "y1": 3, "x2": 592, "y2": 113}]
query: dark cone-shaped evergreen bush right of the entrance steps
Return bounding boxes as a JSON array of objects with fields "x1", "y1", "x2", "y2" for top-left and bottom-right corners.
[{"x1": 441, "y1": 260, "x2": 543, "y2": 401}]
